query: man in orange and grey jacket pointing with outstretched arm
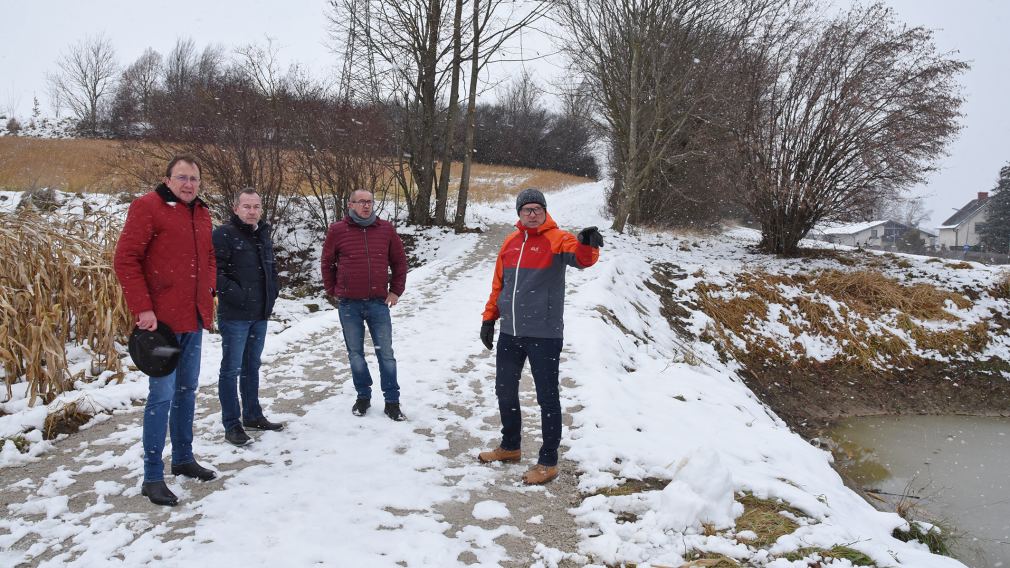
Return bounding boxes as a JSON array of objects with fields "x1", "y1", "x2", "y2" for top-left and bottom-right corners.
[{"x1": 478, "y1": 188, "x2": 603, "y2": 485}]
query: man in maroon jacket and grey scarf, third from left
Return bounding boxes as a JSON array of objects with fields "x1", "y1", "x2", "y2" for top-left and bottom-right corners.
[{"x1": 322, "y1": 190, "x2": 407, "y2": 420}]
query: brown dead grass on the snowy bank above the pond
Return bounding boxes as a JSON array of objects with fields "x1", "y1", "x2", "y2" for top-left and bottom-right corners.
[{"x1": 695, "y1": 270, "x2": 990, "y2": 371}]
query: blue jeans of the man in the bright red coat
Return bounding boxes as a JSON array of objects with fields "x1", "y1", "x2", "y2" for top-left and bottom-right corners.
[{"x1": 143, "y1": 329, "x2": 203, "y2": 482}]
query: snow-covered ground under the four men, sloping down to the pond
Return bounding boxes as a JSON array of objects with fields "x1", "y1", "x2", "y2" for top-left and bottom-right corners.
[{"x1": 0, "y1": 183, "x2": 984, "y2": 568}]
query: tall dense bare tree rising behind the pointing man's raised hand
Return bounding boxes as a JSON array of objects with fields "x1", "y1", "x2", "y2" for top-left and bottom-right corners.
[{"x1": 558, "y1": 0, "x2": 759, "y2": 231}]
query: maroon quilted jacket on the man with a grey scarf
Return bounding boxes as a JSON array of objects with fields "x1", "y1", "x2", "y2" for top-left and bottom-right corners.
[{"x1": 322, "y1": 215, "x2": 407, "y2": 300}]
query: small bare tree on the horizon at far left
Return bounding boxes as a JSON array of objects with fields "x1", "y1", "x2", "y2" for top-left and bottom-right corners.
[{"x1": 48, "y1": 35, "x2": 118, "y2": 134}]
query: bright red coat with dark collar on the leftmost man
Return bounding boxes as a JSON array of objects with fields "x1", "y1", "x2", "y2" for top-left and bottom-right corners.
[{"x1": 114, "y1": 184, "x2": 217, "y2": 334}]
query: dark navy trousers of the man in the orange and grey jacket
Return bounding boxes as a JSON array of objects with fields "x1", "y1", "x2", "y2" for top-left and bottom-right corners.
[{"x1": 495, "y1": 334, "x2": 562, "y2": 466}]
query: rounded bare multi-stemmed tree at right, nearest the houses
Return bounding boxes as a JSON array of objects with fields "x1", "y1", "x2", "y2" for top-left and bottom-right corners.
[{"x1": 736, "y1": 4, "x2": 968, "y2": 255}]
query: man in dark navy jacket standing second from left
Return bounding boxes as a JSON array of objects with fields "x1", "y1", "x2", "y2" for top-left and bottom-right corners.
[{"x1": 214, "y1": 188, "x2": 284, "y2": 446}]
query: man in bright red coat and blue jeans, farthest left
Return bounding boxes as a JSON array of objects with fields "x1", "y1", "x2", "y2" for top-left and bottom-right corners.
[{"x1": 114, "y1": 156, "x2": 217, "y2": 505}]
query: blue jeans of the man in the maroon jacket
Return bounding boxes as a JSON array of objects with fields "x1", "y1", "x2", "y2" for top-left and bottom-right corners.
[{"x1": 337, "y1": 298, "x2": 400, "y2": 402}]
